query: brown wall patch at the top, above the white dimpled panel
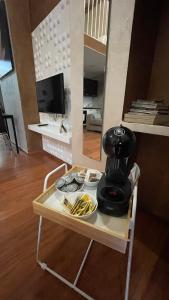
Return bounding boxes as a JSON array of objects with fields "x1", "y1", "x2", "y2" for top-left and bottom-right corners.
[{"x1": 29, "y1": 0, "x2": 60, "y2": 31}]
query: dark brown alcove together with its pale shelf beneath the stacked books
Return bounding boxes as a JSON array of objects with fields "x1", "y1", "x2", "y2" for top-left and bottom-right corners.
[{"x1": 122, "y1": 0, "x2": 169, "y2": 136}]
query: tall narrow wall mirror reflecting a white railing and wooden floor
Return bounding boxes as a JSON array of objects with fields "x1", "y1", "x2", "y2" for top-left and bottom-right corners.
[{"x1": 83, "y1": 0, "x2": 109, "y2": 160}]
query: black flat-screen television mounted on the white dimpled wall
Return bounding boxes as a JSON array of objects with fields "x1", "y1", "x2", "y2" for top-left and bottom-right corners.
[{"x1": 36, "y1": 73, "x2": 65, "y2": 114}]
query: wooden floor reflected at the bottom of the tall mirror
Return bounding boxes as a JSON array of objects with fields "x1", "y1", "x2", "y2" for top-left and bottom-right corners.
[{"x1": 83, "y1": 128, "x2": 101, "y2": 160}]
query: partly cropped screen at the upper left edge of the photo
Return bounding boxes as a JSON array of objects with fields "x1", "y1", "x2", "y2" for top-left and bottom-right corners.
[{"x1": 0, "y1": 0, "x2": 13, "y2": 78}]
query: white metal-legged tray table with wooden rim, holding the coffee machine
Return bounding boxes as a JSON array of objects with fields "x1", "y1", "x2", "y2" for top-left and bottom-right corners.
[{"x1": 33, "y1": 164, "x2": 140, "y2": 300}]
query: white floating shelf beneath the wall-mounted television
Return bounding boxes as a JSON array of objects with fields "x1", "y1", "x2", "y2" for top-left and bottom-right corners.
[{"x1": 28, "y1": 124, "x2": 72, "y2": 144}]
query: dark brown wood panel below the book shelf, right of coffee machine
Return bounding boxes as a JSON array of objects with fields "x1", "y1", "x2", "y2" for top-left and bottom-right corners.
[{"x1": 137, "y1": 134, "x2": 169, "y2": 221}]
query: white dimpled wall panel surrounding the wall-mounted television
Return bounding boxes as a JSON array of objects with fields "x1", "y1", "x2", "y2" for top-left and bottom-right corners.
[{"x1": 32, "y1": 0, "x2": 72, "y2": 163}]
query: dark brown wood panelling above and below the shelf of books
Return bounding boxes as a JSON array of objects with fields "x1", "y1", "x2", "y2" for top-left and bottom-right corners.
[{"x1": 124, "y1": 0, "x2": 169, "y2": 221}]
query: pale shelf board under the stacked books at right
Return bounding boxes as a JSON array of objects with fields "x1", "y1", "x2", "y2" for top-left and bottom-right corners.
[{"x1": 122, "y1": 121, "x2": 169, "y2": 136}]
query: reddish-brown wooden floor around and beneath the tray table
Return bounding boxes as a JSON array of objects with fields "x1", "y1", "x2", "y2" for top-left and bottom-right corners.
[{"x1": 0, "y1": 149, "x2": 169, "y2": 300}]
